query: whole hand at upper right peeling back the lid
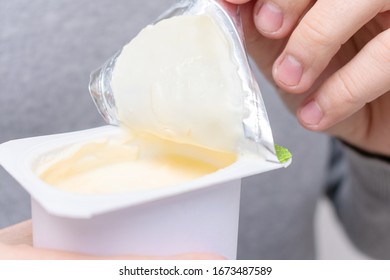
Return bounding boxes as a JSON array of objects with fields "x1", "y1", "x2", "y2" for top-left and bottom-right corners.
[{"x1": 226, "y1": 0, "x2": 390, "y2": 156}]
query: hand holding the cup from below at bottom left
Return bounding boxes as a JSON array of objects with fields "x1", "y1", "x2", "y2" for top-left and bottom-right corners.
[{"x1": 0, "y1": 221, "x2": 222, "y2": 260}]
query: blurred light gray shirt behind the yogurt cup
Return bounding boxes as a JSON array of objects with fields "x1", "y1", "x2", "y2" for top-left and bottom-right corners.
[{"x1": 0, "y1": 0, "x2": 366, "y2": 259}]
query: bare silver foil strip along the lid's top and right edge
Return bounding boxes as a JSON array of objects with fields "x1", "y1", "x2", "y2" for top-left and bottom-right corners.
[{"x1": 156, "y1": 0, "x2": 279, "y2": 162}]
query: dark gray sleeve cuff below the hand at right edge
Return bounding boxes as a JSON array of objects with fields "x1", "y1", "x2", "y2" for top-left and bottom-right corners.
[{"x1": 328, "y1": 139, "x2": 390, "y2": 259}]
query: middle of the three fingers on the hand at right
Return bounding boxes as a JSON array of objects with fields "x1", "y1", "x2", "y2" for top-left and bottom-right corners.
[{"x1": 273, "y1": 0, "x2": 383, "y2": 93}]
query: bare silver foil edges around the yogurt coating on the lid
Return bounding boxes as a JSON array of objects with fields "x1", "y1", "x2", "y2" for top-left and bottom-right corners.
[{"x1": 89, "y1": 0, "x2": 278, "y2": 162}]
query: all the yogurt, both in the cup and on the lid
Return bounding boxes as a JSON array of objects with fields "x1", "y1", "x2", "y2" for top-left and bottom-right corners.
[{"x1": 39, "y1": 15, "x2": 250, "y2": 193}]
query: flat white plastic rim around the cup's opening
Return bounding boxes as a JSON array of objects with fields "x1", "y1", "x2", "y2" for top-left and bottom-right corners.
[{"x1": 0, "y1": 126, "x2": 291, "y2": 218}]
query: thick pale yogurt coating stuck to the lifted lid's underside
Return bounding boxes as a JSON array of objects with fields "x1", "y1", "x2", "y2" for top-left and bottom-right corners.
[{"x1": 112, "y1": 14, "x2": 244, "y2": 152}]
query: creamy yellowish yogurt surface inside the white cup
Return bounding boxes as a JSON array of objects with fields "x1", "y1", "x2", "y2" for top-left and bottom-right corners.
[{"x1": 38, "y1": 132, "x2": 236, "y2": 194}]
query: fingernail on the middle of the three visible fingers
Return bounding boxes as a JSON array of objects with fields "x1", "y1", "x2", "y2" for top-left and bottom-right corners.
[{"x1": 275, "y1": 55, "x2": 303, "y2": 86}]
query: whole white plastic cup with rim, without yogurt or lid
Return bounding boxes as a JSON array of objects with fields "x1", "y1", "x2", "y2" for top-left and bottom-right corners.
[{"x1": 0, "y1": 126, "x2": 289, "y2": 259}]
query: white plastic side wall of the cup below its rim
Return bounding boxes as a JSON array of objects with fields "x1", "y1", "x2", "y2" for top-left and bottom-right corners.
[{"x1": 32, "y1": 180, "x2": 241, "y2": 259}]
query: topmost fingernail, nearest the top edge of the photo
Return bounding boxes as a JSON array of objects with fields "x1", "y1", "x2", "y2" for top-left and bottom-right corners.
[{"x1": 256, "y1": 2, "x2": 283, "y2": 33}]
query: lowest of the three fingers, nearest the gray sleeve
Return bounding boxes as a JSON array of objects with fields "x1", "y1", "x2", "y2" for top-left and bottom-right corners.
[{"x1": 297, "y1": 29, "x2": 390, "y2": 132}]
